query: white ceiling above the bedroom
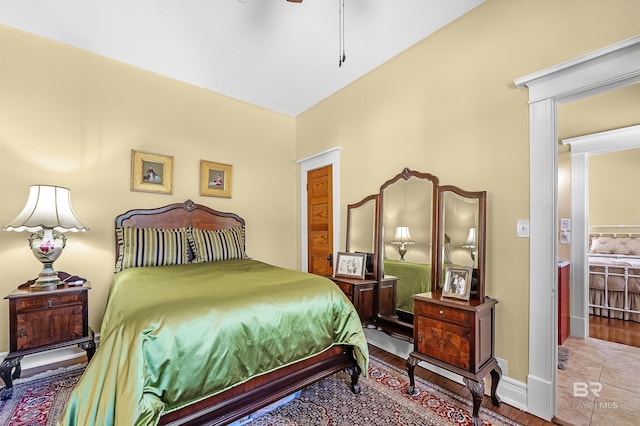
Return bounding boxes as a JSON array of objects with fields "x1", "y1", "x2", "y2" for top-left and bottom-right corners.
[{"x1": 0, "y1": 0, "x2": 485, "y2": 116}]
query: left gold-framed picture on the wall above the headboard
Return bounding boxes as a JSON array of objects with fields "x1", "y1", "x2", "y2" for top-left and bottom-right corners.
[{"x1": 131, "y1": 149, "x2": 173, "y2": 194}]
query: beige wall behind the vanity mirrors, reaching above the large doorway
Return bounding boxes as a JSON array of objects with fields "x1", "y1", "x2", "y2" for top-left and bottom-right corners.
[{"x1": 296, "y1": 0, "x2": 640, "y2": 381}]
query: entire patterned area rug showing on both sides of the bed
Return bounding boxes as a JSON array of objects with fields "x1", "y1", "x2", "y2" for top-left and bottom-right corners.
[{"x1": 0, "y1": 357, "x2": 520, "y2": 426}]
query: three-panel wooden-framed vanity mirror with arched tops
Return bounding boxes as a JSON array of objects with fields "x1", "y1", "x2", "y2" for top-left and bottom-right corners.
[{"x1": 345, "y1": 168, "x2": 486, "y2": 340}]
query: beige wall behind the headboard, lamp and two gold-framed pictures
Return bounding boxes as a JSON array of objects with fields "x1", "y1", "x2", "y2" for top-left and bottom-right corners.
[{"x1": 0, "y1": 26, "x2": 298, "y2": 351}]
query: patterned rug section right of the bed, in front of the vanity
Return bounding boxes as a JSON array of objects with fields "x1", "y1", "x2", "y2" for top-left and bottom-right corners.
[{"x1": 244, "y1": 357, "x2": 520, "y2": 426}]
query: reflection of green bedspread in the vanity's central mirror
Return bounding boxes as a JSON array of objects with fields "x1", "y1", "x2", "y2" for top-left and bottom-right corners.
[{"x1": 384, "y1": 259, "x2": 431, "y2": 313}]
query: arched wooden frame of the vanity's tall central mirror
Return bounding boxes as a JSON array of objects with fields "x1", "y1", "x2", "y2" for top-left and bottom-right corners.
[{"x1": 376, "y1": 167, "x2": 441, "y2": 289}]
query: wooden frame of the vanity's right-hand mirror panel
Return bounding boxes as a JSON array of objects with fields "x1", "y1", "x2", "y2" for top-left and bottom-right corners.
[{"x1": 433, "y1": 185, "x2": 487, "y2": 302}]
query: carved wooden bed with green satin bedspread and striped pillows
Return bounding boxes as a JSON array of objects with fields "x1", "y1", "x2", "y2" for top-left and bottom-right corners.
[{"x1": 58, "y1": 201, "x2": 368, "y2": 425}]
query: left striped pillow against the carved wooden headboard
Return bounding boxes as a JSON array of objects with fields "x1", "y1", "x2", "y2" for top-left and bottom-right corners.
[{"x1": 116, "y1": 227, "x2": 189, "y2": 272}]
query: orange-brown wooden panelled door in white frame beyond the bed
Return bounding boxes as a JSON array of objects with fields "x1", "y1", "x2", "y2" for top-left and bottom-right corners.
[{"x1": 307, "y1": 165, "x2": 333, "y2": 275}]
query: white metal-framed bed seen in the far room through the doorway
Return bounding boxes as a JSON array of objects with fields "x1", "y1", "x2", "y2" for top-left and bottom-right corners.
[{"x1": 588, "y1": 225, "x2": 640, "y2": 322}]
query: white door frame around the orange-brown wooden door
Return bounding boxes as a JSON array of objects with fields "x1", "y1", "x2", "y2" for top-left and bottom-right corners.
[{"x1": 296, "y1": 147, "x2": 342, "y2": 272}]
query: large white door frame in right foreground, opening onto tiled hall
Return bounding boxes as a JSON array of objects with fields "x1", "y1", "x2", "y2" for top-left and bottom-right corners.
[{"x1": 514, "y1": 36, "x2": 640, "y2": 420}]
